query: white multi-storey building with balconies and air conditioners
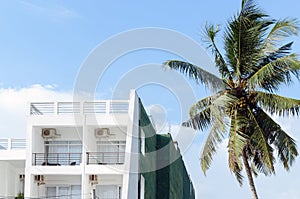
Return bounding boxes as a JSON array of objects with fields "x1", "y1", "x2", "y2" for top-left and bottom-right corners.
[{"x1": 0, "y1": 91, "x2": 194, "y2": 199}]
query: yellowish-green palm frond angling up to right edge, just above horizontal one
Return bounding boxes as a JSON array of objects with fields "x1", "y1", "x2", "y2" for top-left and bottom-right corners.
[{"x1": 248, "y1": 54, "x2": 300, "y2": 92}]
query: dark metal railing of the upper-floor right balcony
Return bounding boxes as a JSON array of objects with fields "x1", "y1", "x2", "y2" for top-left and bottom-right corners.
[{"x1": 86, "y1": 151, "x2": 125, "y2": 164}]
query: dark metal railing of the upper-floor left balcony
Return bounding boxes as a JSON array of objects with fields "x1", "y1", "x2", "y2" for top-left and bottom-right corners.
[{"x1": 32, "y1": 153, "x2": 82, "y2": 166}]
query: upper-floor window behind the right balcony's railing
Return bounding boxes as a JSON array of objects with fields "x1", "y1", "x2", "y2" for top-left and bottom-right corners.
[{"x1": 97, "y1": 141, "x2": 126, "y2": 164}]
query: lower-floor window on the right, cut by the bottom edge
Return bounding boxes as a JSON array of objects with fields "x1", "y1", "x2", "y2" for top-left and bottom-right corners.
[{"x1": 96, "y1": 185, "x2": 122, "y2": 199}]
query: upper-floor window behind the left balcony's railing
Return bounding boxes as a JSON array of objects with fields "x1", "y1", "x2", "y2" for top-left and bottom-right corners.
[{"x1": 45, "y1": 141, "x2": 82, "y2": 165}]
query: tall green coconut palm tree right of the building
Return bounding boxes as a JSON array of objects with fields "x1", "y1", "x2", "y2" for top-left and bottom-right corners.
[{"x1": 165, "y1": 0, "x2": 300, "y2": 199}]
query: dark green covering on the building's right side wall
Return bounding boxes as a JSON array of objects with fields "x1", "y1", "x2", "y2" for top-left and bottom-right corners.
[{"x1": 139, "y1": 99, "x2": 195, "y2": 199}]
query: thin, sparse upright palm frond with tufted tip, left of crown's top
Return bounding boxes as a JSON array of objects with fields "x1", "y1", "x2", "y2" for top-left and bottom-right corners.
[{"x1": 203, "y1": 24, "x2": 231, "y2": 78}]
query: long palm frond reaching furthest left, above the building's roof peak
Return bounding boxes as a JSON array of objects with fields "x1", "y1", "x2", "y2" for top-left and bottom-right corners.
[{"x1": 164, "y1": 60, "x2": 224, "y2": 91}]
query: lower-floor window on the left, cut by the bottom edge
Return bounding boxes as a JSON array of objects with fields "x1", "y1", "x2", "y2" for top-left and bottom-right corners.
[{"x1": 46, "y1": 185, "x2": 81, "y2": 199}]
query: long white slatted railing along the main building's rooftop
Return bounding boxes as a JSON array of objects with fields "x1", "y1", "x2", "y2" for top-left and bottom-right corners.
[{"x1": 29, "y1": 100, "x2": 129, "y2": 115}]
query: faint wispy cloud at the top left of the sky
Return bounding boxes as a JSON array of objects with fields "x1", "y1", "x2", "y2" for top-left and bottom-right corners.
[{"x1": 20, "y1": 1, "x2": 79, "y2": 22}]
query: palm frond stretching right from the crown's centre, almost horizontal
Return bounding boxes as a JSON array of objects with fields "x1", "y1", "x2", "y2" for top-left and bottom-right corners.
[{"x1": 250, "y1": 91, "x2": 300, "y2": 116}]
